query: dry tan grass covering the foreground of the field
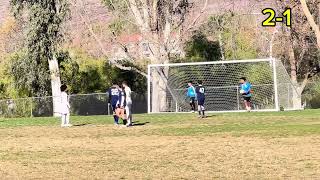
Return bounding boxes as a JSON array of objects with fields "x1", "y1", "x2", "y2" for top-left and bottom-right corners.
[{"x1": 0, "y1": 126, "x2": 320, "y2": 179}]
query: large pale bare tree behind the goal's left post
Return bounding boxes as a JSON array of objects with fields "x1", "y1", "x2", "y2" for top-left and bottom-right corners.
[{"x1": 100, "y1": 0, "x2": 208, "y2": 112}]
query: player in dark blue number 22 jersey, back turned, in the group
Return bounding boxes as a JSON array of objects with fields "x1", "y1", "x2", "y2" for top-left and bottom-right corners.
[{"x1": 108, "y1": 83, "x2": 120, "y2": 125}]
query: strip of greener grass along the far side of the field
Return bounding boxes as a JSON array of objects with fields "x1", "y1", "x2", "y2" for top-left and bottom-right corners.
[{"x1": 0, "y1": 110, "x2": 320, "y2": 137}]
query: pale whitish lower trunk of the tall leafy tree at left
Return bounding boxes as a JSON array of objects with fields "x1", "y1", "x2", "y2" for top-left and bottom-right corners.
[{"x1": 49, "y1": 56, "x2": 61, "y2": 117}]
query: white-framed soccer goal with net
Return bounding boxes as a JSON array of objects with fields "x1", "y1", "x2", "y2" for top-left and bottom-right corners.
[{"x1": 148, "y1": 59, "x2": 301, "y2": 113}]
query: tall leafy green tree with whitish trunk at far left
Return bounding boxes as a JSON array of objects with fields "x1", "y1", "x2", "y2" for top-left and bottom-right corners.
[{"x1": 11, "y1": 0, "x2": 69, "y2": 115}]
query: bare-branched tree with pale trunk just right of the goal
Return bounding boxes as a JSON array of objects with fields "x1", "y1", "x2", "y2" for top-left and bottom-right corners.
[{"x1": 277, "y1": 1, "x2": 319, "y2": 108}]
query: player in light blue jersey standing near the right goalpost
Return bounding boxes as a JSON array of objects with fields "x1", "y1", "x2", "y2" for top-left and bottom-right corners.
[{"x1": 240, "y1": 77, "x2": 252, "y2": 112}]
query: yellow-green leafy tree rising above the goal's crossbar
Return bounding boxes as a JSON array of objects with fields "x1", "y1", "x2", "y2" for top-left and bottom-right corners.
[{"x1": 200, "y1": 12, "x2": 259, "y2": 60}]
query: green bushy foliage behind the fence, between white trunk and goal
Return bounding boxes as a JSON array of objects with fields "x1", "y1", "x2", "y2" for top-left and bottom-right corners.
[{"x1": 57, "y1": 50, "x2": 146, "y2": 94}]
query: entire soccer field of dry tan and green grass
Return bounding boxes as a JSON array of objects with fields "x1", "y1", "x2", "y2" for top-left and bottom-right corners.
[{"x1": 0, "y1": 110, "x2": 320, "y2": 179}]
